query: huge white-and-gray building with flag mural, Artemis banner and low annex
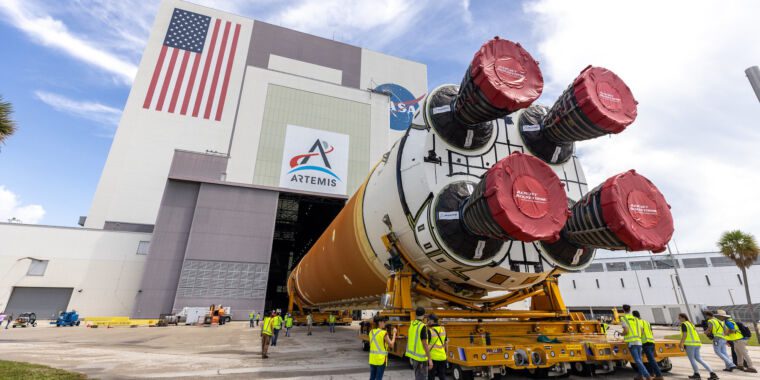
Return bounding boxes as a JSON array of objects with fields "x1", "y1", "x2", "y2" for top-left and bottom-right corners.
[{"x1": 0, "y1": 0, "x2": 428, "y2": 318}]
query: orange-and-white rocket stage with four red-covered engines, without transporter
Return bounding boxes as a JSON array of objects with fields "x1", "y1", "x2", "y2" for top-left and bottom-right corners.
[{"x1": 288, "y1": 37, "x2": 673, "y2": 306}]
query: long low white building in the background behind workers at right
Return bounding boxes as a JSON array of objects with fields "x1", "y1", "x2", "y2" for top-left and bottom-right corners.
[{"x1": 559, "y1": 254, "x2": 760, "y2": 307}]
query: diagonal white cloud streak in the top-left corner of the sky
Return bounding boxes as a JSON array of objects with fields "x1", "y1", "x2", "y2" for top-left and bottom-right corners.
[{"x1": 0, "y1": 0, "x2": 137, "y2": 83}]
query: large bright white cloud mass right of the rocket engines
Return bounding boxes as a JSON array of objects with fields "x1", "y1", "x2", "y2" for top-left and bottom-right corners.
[{"x1": 525, "y1": 0, "x2": 760, "y2": 251}]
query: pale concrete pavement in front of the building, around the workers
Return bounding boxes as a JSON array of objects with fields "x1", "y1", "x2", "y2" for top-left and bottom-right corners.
[{"x1": 0, "y1": 323, "x2": 760, "y2": 380}]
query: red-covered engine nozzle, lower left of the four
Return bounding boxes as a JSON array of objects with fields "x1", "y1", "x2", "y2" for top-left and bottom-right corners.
[{"x1": 462, "y1": 152, "x2": 569, "y2": 242}]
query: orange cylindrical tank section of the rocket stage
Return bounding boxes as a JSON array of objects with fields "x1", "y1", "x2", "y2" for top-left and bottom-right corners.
[{"x1": 288, "y1": 183, "x2": 387, "y2": 306}]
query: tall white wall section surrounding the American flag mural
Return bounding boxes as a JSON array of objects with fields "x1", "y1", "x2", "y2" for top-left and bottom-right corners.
[{"x1": 85, "y1": 0, "x2": 253, "y2": 228}]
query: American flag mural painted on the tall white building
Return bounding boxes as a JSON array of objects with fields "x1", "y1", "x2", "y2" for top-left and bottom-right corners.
[{"x1": 143, "y1": 8, "x2": 240, "y2": 121}]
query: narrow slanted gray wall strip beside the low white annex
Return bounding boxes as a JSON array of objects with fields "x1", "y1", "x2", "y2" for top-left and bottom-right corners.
[{"x1": 132, "y1": 180, "x2": 200, "y2": 318}]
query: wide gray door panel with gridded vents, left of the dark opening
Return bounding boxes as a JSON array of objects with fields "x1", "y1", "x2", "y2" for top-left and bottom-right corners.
[{"x1": 173, "y1": 183, "x2": 278, "y2": 319}]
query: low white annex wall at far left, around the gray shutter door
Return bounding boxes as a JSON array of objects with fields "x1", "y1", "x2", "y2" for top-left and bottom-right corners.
[{"x1": 0, "y1": 223, "x2": 151, "y2": 317}]
